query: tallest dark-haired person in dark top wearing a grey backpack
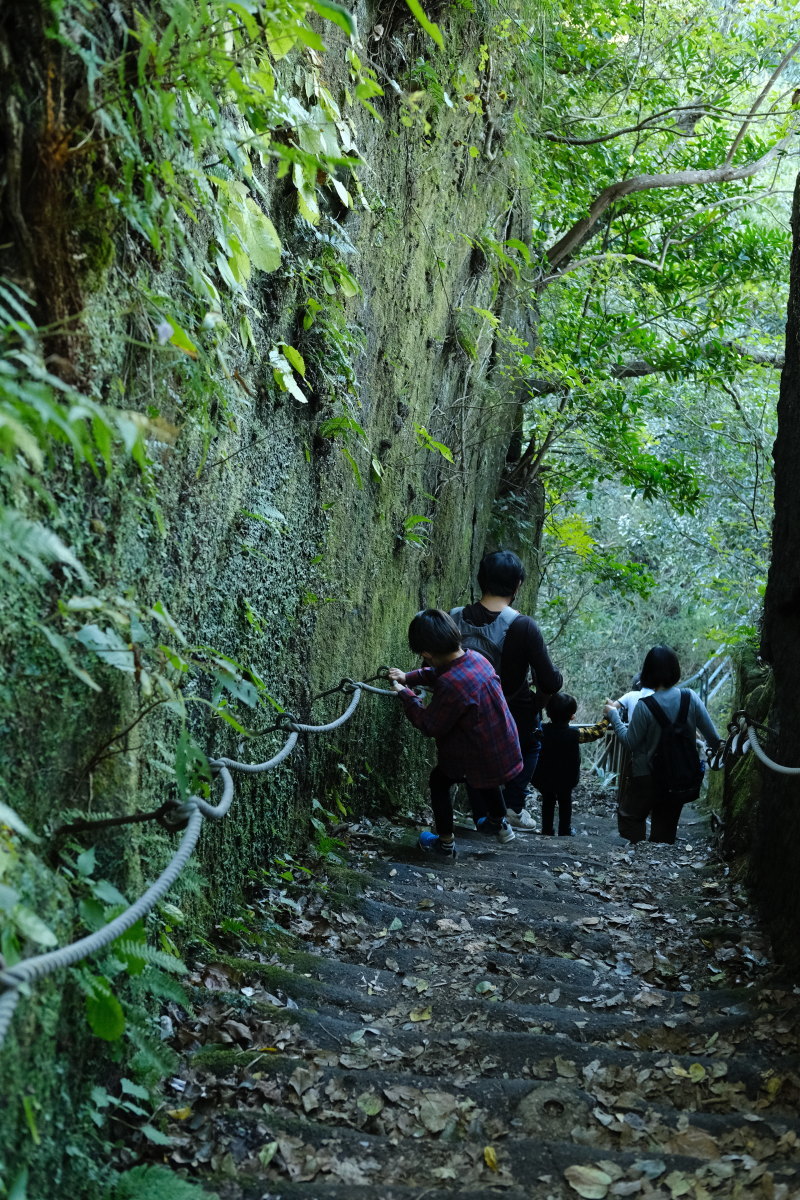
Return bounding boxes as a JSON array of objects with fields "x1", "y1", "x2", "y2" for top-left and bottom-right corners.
[{"x1": 451, "y1": 550, "x2": 564, "y2": 832}]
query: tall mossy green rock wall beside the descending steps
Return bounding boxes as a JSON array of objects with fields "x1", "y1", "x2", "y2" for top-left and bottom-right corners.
[{"x1": 0, "y1": 2, "x2": 537, "y2": 1180}]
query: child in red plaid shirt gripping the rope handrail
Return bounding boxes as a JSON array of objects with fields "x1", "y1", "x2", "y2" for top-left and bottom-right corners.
[{"x1": 389, "y1": 608, "x2": 522, "y2": 858}]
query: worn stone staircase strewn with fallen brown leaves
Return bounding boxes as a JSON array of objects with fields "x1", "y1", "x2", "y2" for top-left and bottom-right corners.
[{"x1": 168, "y1": 797, "x2": 800, "y2": 1200}]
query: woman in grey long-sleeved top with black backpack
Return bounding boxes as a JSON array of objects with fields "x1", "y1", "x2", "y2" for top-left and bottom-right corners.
[{"x1": 604, "y1": 646, "x2": 720, "y2": 844}]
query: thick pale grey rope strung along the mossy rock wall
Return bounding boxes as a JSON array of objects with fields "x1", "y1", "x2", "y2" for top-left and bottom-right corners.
[{"x1": 0, "y1": 682, "x2": 395, "y2": 1045}]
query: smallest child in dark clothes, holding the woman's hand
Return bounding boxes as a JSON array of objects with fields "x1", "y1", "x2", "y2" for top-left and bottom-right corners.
[{"x1": 534, "y1": 692, "x2": 609, "y2": 838}]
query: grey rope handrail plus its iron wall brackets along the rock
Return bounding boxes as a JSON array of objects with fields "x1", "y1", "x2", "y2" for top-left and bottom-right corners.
[{"x1": 0, "y1": 667, "x2": 395, "y2": 1045}]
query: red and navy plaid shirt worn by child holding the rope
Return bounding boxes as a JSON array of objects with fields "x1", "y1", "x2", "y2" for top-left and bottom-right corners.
[{"x1": 399, "y1": 650, "x2": 522, "y2": 787}]
